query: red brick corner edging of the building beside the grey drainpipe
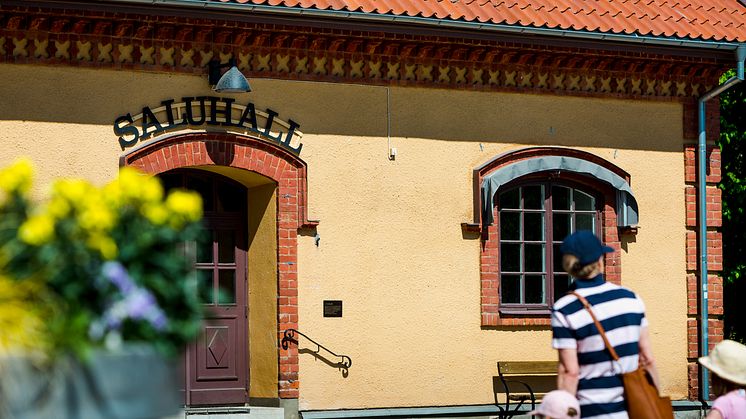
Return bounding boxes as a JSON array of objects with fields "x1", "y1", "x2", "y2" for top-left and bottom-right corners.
[{"x1": 684, "y1": 144, "x2": 723, "y2": 400}]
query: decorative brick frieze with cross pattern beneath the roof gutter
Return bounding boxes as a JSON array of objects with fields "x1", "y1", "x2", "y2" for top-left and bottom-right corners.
[{"x1": 0, "y1": 6, "x2": 723, "y2": 100}]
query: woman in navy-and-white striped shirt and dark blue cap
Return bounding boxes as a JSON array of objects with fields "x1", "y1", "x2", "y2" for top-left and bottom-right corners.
[{"x1": 552, "y1": 231, "x2": 658, "y2": 419}]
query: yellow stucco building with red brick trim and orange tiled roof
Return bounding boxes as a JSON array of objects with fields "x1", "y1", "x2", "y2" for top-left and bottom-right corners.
[{"x1": 0, "y1": 0, "x2": 746, "y2": 414}]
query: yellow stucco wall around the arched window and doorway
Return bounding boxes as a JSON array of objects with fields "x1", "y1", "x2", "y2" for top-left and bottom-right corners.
[{"x1": 0, "y1": 65, "x2": 687, "y2": 409}]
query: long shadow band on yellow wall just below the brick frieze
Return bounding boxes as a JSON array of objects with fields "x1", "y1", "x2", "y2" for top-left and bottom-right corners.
[{"x1": 0, "y1": 65, "x2": 682, "y2": 152}]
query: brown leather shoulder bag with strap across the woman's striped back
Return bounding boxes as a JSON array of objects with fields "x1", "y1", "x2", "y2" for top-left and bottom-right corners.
[{"x1": 571, "y1": 292, "x2": 673, "y2": 419}]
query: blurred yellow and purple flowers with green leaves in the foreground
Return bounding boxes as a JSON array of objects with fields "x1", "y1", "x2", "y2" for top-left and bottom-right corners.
[{"x1": 0, "y1": 162, "x2": 203, "y2": 358}]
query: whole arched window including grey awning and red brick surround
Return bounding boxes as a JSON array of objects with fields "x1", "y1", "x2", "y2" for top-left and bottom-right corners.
[{"x1": 474, "y1": 147, "x2": 639, "y2": 326}]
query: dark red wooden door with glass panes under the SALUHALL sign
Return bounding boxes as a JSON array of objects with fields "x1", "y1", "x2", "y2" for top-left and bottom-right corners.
[{"x1": 161, "y1": 171, "x2": 249, "y2": 406}]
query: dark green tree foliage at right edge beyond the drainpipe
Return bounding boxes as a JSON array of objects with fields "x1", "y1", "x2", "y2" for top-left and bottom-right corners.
[{"x1": 718, "y1": 70, "x2": 746, "y2": 342}]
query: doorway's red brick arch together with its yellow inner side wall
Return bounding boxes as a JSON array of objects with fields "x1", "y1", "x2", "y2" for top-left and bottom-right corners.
[{"x1": 120, "y1": 133, "x2": 316, "y2": 405}]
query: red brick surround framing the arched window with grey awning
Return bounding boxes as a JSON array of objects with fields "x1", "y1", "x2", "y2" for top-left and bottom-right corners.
[{"x1": 474, "y1": 147, "x2": 630, "y2": 327}]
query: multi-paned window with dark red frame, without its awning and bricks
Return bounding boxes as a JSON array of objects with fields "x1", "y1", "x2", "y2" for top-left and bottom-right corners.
[{"x1": 497, "y1": 180, "x2": 602, "y2": 313}]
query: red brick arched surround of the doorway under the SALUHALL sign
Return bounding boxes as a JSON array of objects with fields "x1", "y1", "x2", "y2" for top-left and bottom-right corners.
[{"x1": 120, "y1": 133, "x2": 314, "y2": 398}]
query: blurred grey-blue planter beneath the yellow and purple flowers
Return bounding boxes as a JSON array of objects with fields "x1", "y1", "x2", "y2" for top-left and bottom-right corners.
[{"x1": 0, "y1": 345, "x2": 183, "y2": 419}]
